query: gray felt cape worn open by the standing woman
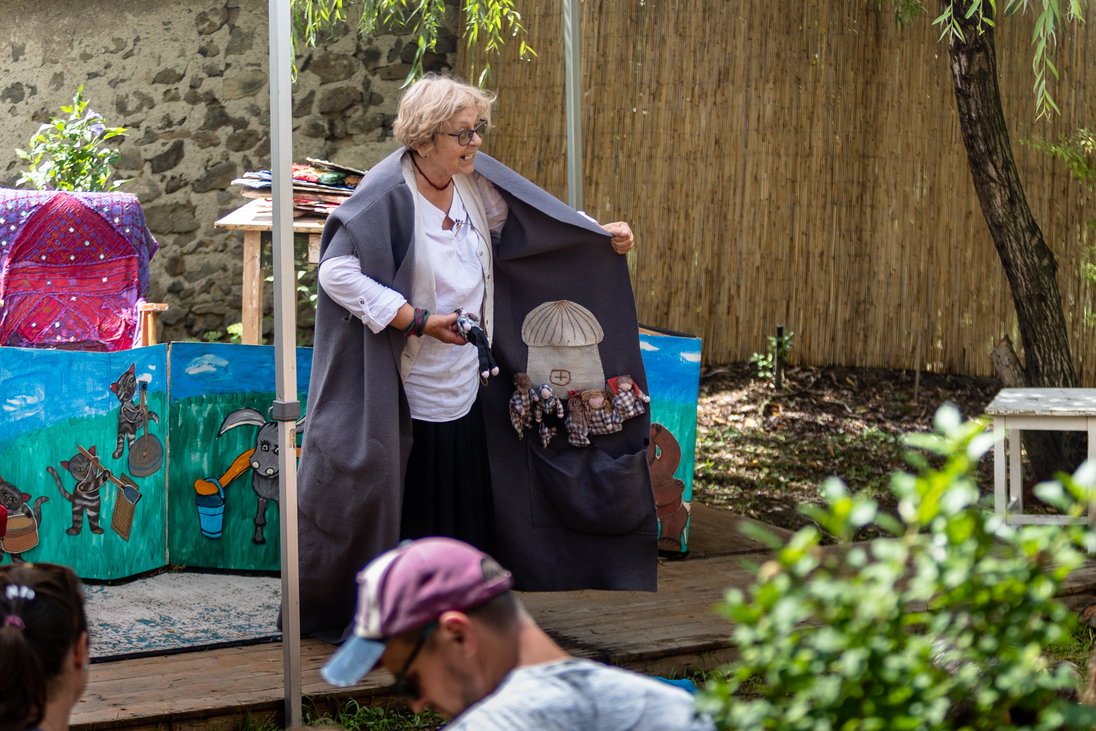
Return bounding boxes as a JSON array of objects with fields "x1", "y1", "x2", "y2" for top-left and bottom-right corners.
[{"x1": 298, "y1": 145, "x2": 658, "y2": 639}]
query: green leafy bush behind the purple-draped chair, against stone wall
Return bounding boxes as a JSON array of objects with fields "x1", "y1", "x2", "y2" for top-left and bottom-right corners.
[{"x1": 15, "y1": 87, "x2": 126, "y2": 191}]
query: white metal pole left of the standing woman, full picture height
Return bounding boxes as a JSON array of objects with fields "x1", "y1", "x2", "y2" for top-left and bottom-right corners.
[{"x1": 270, "y1": 0, "x2": 301, "y2": 729}]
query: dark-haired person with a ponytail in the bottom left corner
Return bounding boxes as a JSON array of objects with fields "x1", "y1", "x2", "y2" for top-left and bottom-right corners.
[{"x1": 0, "y1": 563, "x2": 88, "y2": 731}]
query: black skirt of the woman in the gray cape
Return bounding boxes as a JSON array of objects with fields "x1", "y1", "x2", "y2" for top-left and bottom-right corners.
[{"x1": 400, "y1": 399, "x2": 494, "y2": 553}]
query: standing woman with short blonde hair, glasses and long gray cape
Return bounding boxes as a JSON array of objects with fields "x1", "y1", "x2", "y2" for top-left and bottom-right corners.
[{"x1": 300, "y1": 76, "x2": 654, "y2": 637}]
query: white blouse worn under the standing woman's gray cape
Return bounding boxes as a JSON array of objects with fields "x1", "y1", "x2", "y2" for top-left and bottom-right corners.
[{"x1": 319, "y1": 173, "x2": 509, "y2": 422}]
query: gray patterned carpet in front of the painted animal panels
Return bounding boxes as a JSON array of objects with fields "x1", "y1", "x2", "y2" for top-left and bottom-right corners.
[{"x1": 84, "y1": 573, "x2": 282, "y2": 662}]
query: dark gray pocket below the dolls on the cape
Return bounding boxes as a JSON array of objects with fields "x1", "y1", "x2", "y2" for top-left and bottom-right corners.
[{"x1": 528, "y1": 444, "x2": 655, "y2": 536}]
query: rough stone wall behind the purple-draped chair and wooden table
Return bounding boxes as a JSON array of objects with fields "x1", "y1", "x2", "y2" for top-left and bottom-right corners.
[{"x1": 0, "y1": 0, "x2": 457, "y2": 340}]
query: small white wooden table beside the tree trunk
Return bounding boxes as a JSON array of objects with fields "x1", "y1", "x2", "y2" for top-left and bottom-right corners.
[{"x1": 985, "y1": 388, "x2": 1096, "y2": 525}]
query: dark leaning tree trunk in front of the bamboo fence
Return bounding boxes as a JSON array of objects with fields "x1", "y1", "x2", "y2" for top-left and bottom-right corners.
[{"x1": 941, "y1": 0, "x2": 1077, "y2": 479}]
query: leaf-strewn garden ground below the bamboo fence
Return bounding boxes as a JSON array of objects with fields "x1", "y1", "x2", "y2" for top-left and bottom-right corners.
[{"x1": 693, "y1": 364, "x2": 1001, "y2": 538}]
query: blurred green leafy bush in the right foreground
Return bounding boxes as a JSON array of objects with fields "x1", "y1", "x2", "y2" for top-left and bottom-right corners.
[{"x1": 698, "y1": 406, "x2": 1096, "y2": 731}]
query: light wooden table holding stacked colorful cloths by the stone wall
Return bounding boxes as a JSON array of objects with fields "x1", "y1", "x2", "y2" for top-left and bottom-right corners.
[{"x1": 214, "y1": 198, "x2": 327, "y2": 345}]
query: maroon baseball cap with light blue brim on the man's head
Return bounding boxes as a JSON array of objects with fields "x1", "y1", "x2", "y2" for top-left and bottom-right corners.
[{"x1": 320, "y1": 538, "x2": 514, "y2": 687}]
